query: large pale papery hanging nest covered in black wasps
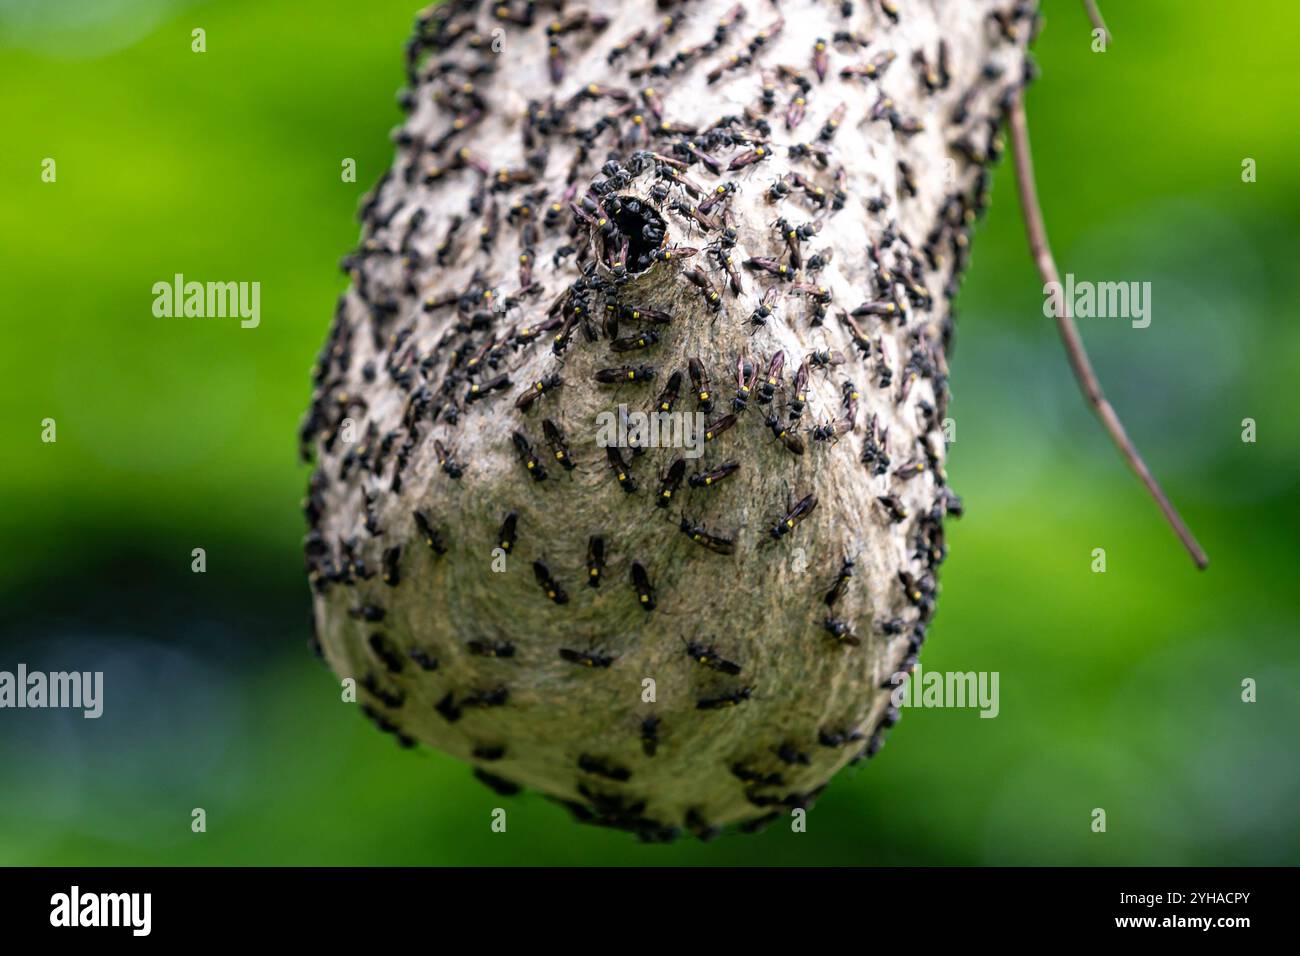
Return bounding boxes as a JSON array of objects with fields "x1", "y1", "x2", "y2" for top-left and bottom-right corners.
[{"x1": 302, "y1": 0, "x2": 1036, "y2": 839}]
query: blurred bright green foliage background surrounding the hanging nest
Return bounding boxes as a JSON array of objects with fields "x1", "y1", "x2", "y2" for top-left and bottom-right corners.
[{"x1": 0, "y1": 0, "x2": 1300, "y2": 865}]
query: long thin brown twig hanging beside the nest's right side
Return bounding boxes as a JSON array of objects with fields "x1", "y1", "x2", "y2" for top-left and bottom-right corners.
[{"x1": 1010, "y1": 94, "x2": 1209, "y2": 570}]
